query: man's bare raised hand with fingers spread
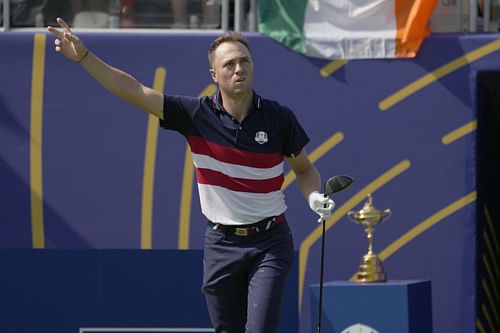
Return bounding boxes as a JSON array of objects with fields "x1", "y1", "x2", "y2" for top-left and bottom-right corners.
[{"x1": 47, "y1": 17, "x2": 89, "y2": 63}]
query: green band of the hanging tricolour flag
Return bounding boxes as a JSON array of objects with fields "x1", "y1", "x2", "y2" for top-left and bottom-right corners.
[{"x1": 259, "y1": 0, "x2": 307, "y2": 53}]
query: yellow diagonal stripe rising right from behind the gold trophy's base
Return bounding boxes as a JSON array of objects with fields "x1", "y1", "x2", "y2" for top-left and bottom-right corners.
[{"x1": 351, "y1": 191, "x2": 477, "y2": 280}]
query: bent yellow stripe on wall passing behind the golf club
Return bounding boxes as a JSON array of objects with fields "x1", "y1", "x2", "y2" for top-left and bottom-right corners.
[{"x1": 299, "y1": 160, "x2": 411, "y2": 309}]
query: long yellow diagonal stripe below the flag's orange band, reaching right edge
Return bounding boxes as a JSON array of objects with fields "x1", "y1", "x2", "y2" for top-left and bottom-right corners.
[{"x1": 379, "y1": 40, "x2": 500, "y2": 111}]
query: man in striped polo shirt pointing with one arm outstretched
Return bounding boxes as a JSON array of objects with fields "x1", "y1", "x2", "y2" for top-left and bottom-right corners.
[{"x1": 48, "y1": 18, "x2": 334, "y2": 333}]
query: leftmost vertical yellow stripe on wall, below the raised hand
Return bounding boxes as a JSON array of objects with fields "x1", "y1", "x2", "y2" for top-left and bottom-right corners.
[{"x1": 30, "y1": 34, "x2": 46, "y2": 249}]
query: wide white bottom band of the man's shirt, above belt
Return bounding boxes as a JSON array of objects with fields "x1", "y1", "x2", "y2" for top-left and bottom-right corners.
[{"x1": 198, "y1": 184, "x2": 286, "y2": 225}]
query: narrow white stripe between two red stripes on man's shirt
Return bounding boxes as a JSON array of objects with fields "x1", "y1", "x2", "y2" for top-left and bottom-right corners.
[{"x1": 192, "y1": 153, "x2": 284, "y2": 180}]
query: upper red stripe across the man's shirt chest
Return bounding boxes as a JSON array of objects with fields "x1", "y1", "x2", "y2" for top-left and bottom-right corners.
[{"x1": 188, "y1": 135, "x2": 283, "y2": 168}]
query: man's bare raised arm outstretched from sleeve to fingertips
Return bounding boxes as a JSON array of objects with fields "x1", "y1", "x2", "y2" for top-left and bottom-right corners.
[{"x1": 48, "y1": 18, "x2": 163, "y2": 119}]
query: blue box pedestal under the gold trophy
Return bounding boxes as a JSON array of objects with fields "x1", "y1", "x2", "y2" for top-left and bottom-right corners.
[{"x1": 311, "y1": 281, "x2": 432, "y2": 333}]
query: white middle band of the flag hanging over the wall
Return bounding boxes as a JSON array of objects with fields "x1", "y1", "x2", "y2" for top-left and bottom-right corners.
[{"x1": 303, "y1": 0, "x2": 396, "y2": 58}]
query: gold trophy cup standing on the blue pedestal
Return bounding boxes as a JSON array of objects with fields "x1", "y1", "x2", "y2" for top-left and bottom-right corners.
[{"x1": 347, "y1": 194, "x2": 391, "y2": 283}]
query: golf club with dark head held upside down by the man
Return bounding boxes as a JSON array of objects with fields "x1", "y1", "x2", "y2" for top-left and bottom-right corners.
[{"x1": 318, "y1": 175, "x2": 354, "y2": 333}]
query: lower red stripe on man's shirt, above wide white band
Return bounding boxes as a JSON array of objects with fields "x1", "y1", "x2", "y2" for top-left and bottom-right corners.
[{"x1": 196, "y1": 168, "x2": 285, "y2": 193}]
